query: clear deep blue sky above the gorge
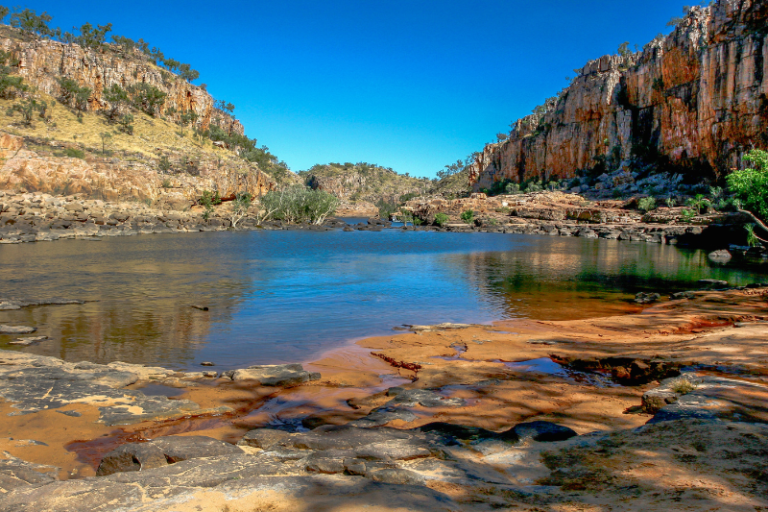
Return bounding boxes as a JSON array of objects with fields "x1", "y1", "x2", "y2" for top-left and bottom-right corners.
[{"x1": 25, "y1": 0, "x2": 684, "y2": 177}]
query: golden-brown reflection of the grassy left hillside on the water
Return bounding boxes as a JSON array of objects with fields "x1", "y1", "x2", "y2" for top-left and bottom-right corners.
[{"x1": 0, "y1": 237, "x2": 250, "y2": 366}]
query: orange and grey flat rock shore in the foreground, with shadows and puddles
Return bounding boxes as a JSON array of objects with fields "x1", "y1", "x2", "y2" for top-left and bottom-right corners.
[{"x1": 0, "y1": 285, "x2": 768, "y2": 512}]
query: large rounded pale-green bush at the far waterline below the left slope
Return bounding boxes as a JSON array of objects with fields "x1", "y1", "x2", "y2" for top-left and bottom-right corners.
[{"x1": 259, "y1": 185, "x2": 339, "y2": 224}]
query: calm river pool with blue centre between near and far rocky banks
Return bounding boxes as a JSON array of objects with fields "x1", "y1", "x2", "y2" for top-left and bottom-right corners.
[{"x1": 0, "y1": 230, "x2": 764, "y2": 370}]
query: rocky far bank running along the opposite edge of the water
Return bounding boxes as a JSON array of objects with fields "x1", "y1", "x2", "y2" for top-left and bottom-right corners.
[{"x1": 0, "y1": 191, "x2": 765, "y2": 258}]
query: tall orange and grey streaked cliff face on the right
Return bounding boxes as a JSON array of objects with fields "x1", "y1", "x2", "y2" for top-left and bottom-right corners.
[{"x1": 470, "y1": 0, "x2": 768, "y2": 190}]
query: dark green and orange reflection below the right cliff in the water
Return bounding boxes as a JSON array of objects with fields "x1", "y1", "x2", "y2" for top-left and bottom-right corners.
[{"x1": 452, "y1": 237, "x2": 749, "y2": 320}]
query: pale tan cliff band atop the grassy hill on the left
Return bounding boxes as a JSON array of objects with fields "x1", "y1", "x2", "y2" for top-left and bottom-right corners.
[{"x1": 0, "y1": 27, "x2": 244, "y2": 135}]
